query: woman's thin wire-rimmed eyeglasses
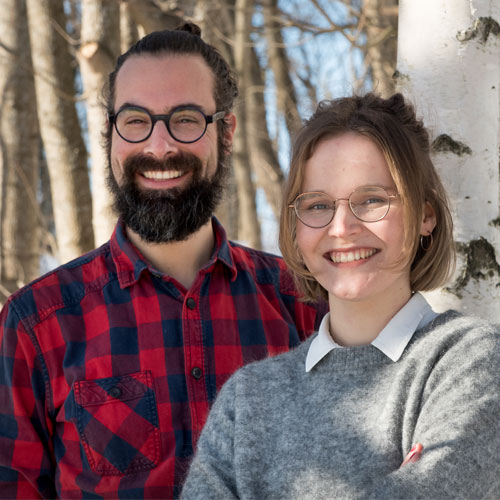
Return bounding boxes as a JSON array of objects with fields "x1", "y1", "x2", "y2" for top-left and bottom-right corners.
[{"x1": 288, "y1": 186, "x2": 399, "y2": 228}]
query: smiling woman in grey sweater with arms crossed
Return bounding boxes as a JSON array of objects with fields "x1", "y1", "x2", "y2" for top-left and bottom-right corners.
[{"x1": 183, "y1": 94, "x2": 500, "y2": 499}]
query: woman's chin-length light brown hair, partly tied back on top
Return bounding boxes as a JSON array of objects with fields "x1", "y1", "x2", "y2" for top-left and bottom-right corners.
[{"x1": 279, "y1": 93, "x2": 455, "y2": 300}]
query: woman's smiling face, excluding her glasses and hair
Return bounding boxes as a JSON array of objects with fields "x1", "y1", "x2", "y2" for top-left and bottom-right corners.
[{"x1": 297, "y1": 133, "x2": 411, "y2": 307}]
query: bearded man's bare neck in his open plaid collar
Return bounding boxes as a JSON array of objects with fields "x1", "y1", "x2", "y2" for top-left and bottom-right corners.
[{"x1": 127, "y1": 221, "x2": 215, "y2": 289}]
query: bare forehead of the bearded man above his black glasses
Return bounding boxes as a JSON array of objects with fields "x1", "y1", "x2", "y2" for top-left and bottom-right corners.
[{"x1": 115, "y1": 53, "x2": 215, "y2": 107}]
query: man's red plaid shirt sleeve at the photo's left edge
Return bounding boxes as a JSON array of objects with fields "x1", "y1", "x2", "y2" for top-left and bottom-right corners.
[{"x1": 0, "y1": 303, "x2": 56, "y2": 499}]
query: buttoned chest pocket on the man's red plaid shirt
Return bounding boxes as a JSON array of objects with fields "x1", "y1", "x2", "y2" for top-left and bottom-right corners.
[{"x1": 73, "y1": 371, "x2": 160, "y2": 475}]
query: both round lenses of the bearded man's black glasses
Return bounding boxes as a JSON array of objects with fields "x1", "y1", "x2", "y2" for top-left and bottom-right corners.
[{"x1": 115, "y1": 107, "x2": 207, "y2": 142}]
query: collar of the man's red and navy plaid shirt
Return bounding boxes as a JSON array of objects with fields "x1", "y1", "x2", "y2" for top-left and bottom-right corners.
[{"x1": 110, "y1": 217, "x2": 237, "y2": 288}]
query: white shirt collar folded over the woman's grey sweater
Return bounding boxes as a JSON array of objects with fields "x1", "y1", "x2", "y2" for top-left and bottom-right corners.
[{"x1": 306, "y1": 293, "x2": 437, "y2": 372}]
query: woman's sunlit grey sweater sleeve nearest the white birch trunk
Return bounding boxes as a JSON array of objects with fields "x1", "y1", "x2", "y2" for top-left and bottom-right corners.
[{"x1": 366, "y1": 327, "x2": 500, "y2": 499}]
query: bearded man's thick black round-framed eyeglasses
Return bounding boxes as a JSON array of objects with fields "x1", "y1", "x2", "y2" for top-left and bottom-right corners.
[{"x1": 108, "y1": 106, "x2": 225, "y2": 144}]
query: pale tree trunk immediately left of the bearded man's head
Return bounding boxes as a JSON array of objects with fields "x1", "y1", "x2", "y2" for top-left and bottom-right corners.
[{"x1": 78, "y1": 0, "x2": 120, "y2": 245}]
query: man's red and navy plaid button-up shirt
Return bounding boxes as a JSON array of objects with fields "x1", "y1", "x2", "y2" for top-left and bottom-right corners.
[{"x1": 0, "y1": 219, "x2": 324, "y2": 498}]
